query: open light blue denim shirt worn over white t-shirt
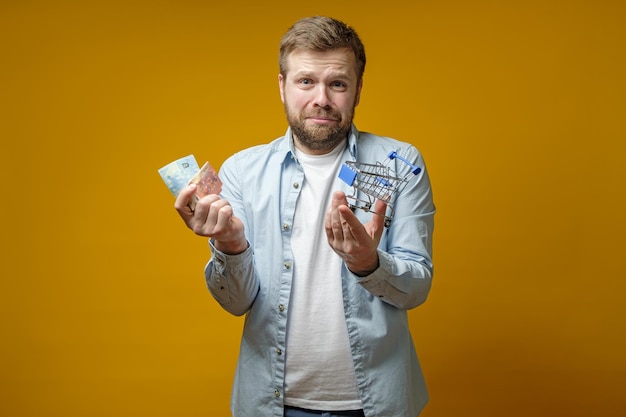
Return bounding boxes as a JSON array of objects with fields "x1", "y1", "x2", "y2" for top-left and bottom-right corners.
[{"x1": 205, "y1": 126, "x2": 435, "y2": 417}]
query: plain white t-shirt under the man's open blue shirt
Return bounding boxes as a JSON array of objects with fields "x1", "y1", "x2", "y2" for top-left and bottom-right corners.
[{"x1": 285, "y1": 144, "x2": 362, "y2": 410}]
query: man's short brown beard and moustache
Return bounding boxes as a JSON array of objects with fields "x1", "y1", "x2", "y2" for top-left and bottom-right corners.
[{"x1": 285, "y1": 102, "x2": 354, "y2": 152}]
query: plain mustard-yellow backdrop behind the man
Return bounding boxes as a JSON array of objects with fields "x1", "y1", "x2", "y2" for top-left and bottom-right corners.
[{"x1": 0, "y1": 0, "x2": 626, "y2": 417}]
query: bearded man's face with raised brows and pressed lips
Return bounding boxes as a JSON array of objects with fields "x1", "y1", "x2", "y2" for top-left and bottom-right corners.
[{"x1": 278, "y1": 49, "x2": 362, "y2": 155}]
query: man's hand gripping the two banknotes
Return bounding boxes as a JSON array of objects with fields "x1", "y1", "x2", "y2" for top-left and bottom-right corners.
[{"x1": 174, "y1": 184, "x2": 248, "y2": 255}]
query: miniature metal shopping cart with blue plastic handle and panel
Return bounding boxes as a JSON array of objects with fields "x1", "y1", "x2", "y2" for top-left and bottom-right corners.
[{"x1": 339, "y1": 151, "x2": 422, "y2": 227}]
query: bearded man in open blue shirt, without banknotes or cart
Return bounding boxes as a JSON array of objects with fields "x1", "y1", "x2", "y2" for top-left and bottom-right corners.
[{"x1": 175, "y1": 17, "x2": 435, "y2": 417}]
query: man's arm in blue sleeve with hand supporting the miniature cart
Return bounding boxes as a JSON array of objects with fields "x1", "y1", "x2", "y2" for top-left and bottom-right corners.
[{"x1": 325, "y1": 150, "x2": 435, "y2": 309}]
